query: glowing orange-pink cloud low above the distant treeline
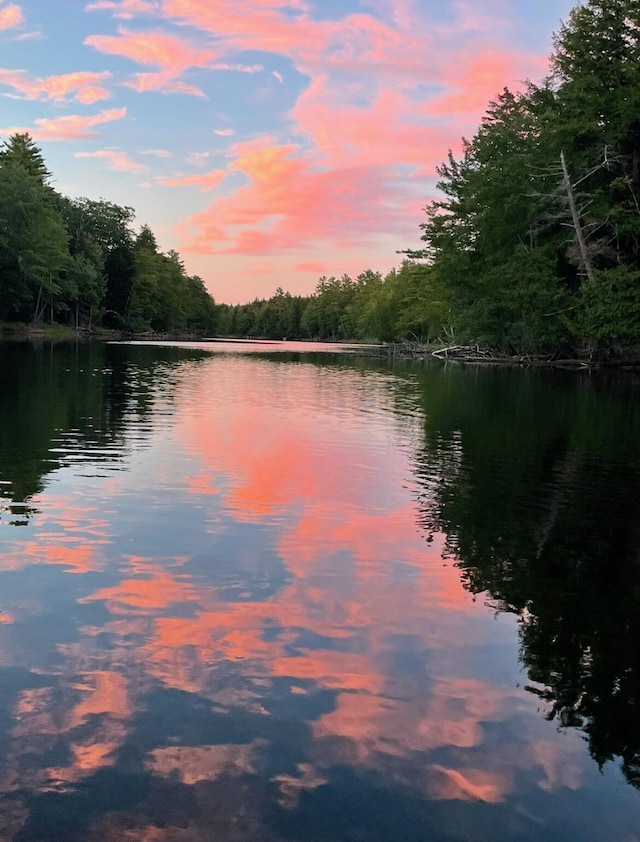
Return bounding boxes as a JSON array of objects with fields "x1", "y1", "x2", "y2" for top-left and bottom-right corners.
[{"x1": 181, "y1": 136, "x2": 416, "y2": 254}]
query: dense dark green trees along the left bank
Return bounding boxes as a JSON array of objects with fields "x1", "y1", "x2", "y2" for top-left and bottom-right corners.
[{"x1": 0, "y1": 134, "x2": 216, "y2": 332}]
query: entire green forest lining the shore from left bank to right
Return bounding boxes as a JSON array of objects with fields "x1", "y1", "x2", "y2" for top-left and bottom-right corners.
[{"x1": 0, "y1": 0, "x2": 640, "y2": 368}]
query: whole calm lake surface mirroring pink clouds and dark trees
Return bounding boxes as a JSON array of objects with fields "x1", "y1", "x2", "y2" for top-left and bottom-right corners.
[{"x1": 0, "y1": 344, "x2": 640, "y2": 842}]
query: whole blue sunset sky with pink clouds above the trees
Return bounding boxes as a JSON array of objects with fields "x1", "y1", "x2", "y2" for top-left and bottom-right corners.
[{"x1": 0, "y1": 0, "x2": 575, "y2": 303}]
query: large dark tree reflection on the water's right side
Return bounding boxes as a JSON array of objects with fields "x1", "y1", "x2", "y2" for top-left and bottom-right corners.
[{"x1": 417, "y1": 367, "x2": 640, "y2": 787}]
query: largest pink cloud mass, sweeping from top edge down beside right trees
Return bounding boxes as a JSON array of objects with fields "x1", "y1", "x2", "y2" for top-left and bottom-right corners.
[{"x1": 163, "y1": 0, "x2": 537, "y2": 288}]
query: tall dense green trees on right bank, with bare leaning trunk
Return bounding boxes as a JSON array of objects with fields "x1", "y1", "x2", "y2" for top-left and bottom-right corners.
[{"x1": 408, "y1": 0, "x2": 640, "y2": 350}]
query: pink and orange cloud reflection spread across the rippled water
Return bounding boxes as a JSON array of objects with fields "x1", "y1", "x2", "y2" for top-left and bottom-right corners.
[{"x1": 0, "y1": 352, "x2": 596, "y2": 839}]
